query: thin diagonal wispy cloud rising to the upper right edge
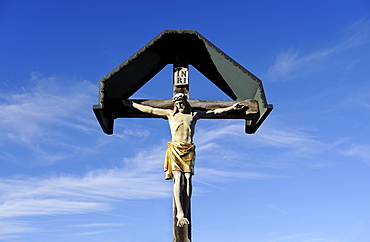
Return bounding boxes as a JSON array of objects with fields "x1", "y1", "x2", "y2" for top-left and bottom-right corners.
[{"x1": 266, "y1": 18, "x2": 370, "y2": 81}]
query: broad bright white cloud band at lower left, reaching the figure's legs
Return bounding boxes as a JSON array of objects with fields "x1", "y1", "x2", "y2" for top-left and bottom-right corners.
[{"x1": 0, "y1": 142, "x2": 172, "y2": 238}]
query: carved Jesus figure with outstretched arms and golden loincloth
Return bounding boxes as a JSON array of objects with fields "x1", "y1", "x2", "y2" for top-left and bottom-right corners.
[{"x1": 123, "y1": 93, "x2": 245, "y2": 227}]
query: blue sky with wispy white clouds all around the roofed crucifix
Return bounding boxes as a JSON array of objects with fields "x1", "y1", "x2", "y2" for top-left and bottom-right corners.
[{"x1": 0, "y1": 0, "x2": 370, "y2": 242}]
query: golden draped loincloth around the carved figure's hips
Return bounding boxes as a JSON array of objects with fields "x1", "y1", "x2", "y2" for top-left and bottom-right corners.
[{"x1": 164, "y1": 141, "x2": 195, "y2": 180}]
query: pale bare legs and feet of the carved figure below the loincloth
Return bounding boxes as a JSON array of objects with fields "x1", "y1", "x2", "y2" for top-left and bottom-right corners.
[{"x1": 172, "y1": 171, "x2": 192, "y2": 227}]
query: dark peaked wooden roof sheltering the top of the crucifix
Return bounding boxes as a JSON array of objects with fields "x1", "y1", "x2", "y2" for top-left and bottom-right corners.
[{"x1": 93, "y1": 30, "x2": 273, "y2": 134}]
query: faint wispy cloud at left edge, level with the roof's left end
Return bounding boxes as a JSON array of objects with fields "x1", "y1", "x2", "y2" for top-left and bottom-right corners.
[{"x1": 0, "y1": 74, "x2": 96, "y2": 136}]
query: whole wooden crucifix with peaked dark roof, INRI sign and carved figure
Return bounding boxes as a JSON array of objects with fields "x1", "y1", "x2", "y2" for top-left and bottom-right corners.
[{"x1": 93, "y1": 30, "x2": 272, "y2": 241}]
